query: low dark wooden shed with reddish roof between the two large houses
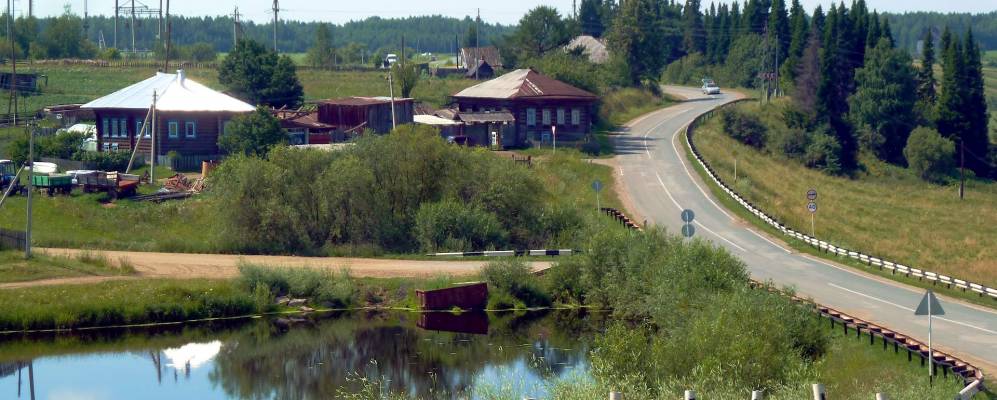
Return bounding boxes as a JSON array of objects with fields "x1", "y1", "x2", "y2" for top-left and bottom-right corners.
[{"x1": 318, "y1": 97, "x2": 415, "y2": 134}]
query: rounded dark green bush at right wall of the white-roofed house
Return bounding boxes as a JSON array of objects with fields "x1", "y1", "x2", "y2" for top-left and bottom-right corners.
[{"x1": 218, "y1": 106, "x2": 287, "y2": 157}]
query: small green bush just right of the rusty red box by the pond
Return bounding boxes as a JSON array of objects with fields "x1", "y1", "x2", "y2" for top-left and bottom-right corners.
[{"x1": 481, "y1": 259, "x2": 550, "y2": 310}]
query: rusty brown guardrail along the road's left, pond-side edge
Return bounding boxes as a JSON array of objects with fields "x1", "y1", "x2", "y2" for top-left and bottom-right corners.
[{"x1": 603, "y1": 165, "x2": 984, "y2": 390}]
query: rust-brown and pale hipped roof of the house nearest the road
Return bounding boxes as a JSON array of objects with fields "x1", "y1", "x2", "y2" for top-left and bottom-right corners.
[{"x1": 454, "y1": 69, "x2": 598, "y2": 100}]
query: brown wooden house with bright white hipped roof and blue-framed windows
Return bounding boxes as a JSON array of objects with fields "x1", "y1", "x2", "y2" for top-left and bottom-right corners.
[{"x1": 80, "y1": 70, "x2": 254, "y2": 163}]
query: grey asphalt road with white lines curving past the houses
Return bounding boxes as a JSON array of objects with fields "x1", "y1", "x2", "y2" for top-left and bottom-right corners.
[{"x1": 614, "y1": 87, "x2": 997, "y2": 376}]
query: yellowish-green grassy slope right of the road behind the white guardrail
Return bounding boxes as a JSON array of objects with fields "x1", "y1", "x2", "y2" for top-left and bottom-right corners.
[{"x1": 694, "y1": 104, "x2": 997, "y2": 286}]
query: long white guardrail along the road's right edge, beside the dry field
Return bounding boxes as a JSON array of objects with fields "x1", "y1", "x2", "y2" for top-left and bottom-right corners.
[{"x1": 685, "y1": 99, "x2": 997, "y2": 300}]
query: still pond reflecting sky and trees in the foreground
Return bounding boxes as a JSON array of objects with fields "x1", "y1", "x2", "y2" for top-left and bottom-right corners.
[{"x1": 0, "y1": 310, "x2": 607, "y2": 399}]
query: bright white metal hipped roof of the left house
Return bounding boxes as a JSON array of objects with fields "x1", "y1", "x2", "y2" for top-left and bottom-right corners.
[{"x1": 80, "y1": 70, "x2": 255, "y2": 113}]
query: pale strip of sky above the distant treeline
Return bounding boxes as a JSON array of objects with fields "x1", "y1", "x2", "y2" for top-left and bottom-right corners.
[{"x1": 11, "y1": 0, "x2": 997, "y2": 24}]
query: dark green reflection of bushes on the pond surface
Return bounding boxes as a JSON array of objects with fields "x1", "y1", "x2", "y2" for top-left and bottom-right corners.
[{"x1": 211, "y1": 313, "x2": 604, "y2": 399}]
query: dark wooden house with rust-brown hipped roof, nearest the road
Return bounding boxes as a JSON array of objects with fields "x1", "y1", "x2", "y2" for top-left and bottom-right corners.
[{"x1": 453, "y1": 69, "x2": 599, "y2": 148}]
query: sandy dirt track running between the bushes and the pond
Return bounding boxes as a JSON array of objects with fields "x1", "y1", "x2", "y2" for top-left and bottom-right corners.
[{"x1": 0, "y1": 249, "x2": 551, "y2": 289}]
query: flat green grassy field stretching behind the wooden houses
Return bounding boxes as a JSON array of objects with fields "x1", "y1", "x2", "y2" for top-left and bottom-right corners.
[{"x1": 0, "y1": 64, "x2": 475, "y2": 113}]
